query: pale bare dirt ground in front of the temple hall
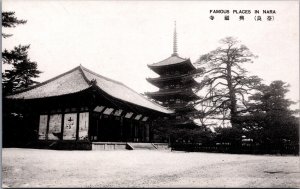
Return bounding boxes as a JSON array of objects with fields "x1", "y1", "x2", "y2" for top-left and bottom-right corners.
[{"x1": 2, "y1": 148, "x2": 300, "y2": 188}]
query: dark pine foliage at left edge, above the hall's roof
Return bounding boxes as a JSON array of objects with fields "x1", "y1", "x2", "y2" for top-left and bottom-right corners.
[{"x1": 2, "y1": 12, "x2": 41, "y2": 96}]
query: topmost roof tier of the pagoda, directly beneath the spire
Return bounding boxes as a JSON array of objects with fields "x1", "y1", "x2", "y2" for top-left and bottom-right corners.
[{"x1": 148, "y1": 55, "x2": 196, "y2": 75}]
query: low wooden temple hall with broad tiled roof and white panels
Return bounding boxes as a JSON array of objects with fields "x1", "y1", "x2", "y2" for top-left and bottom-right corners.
[{"x1": 3, "y1": 66, "x2": 173, "y2": 149}]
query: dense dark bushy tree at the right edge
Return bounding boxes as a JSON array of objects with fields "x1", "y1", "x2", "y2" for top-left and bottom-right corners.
[{"x1": 239, "y1": 80, "x2": 299, "y2": 144}]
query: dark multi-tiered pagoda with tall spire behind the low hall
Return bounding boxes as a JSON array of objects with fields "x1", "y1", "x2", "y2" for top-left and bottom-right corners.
[{"x1": 145, "y1": 23, "x2": 199, "y2": 122}]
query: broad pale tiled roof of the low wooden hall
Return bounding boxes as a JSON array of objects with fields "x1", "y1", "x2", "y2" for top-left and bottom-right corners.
[{"x1": 6, "y1": 66, "x2": 173, "y2": 113}]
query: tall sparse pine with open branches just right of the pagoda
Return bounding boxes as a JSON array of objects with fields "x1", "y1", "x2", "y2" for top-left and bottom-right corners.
[{"x1": 196, "y1": 37, "x2": 261, "y2": 126}]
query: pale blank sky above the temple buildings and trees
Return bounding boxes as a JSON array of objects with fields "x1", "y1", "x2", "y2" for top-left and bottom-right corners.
[{"x1": 2, "y1": 0, "x2": 299, "y2": 108}]
